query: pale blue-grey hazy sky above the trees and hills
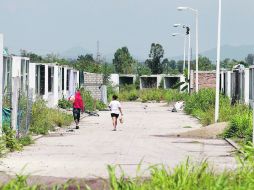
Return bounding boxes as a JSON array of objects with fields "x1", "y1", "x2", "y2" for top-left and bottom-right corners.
[{"x1": 0, "y1": 0, "x2": 254, "y2": 59}]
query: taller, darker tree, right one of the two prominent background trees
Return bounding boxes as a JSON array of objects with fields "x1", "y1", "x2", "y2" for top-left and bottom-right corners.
[{"x1": 145, "y1": 43, "x2": 164, "y2": 74}]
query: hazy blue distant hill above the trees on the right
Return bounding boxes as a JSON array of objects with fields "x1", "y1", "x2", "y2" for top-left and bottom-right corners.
[{"x1": 171, "y1": 45, "x2": 254, "y2": 62}]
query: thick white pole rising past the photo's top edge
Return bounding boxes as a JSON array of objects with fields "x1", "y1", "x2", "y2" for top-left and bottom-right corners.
[{"x1": 215, "y1": 0, "x2": 221, "y2": 122}]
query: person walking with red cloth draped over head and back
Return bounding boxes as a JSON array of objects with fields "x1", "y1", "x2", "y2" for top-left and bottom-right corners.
[{"x1": 72, "y1": 90, "x2": 84, "y2": 129}]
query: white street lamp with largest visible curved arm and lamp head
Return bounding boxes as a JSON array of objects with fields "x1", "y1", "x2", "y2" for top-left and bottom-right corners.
[{"x1": 177, "y1": 7, "x2": 199, "y2": 92}]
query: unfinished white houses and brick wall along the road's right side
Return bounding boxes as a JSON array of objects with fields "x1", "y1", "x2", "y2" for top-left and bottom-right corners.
[{"x1": 190, "y1": 65, "x2": 254, "y2": 107}]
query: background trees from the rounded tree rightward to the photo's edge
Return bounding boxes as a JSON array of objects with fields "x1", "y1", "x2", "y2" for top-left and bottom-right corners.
[{"x1": 113, "y1": 43, "x2": 254, "y2": 74}]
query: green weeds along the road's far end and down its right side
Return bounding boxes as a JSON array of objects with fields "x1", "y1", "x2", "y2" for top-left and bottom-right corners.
[{"x1": 119, "y1": 86, "x2": 252, "y2": 143}]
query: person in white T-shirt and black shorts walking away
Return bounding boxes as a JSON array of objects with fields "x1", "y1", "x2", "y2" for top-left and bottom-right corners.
[{"x1": 109, "y1": 95, "x2": 123, "y2": 131}]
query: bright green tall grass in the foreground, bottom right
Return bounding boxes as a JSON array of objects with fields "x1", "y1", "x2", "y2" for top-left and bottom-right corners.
[{"x1": 108, "y1": 144, "x2": 254, "y2": 190}]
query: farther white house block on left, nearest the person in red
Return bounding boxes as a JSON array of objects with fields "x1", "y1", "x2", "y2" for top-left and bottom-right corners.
[{"x1": 29, "y1": 63, "x2": 79, "y2": 107}]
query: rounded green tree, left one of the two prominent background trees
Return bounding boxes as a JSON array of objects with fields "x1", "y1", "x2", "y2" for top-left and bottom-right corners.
[{"x1": 113, "y1": 47, "x2": 135, "y2": 74}]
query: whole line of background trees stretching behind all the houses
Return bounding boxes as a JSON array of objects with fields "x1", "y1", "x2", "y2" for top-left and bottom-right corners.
[{"x1": 21, "y1": 43, "x2": 254, "y2": 81}]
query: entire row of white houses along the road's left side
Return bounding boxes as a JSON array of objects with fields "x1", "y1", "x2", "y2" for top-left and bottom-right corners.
[{"x1": 2, "y1": 54, "x2": 79, "y2": 107}]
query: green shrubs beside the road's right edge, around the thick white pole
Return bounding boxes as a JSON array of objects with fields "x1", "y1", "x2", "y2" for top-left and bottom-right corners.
[{"x1": 182, "y1": 89, "x2": 252, "y2": 143}]
